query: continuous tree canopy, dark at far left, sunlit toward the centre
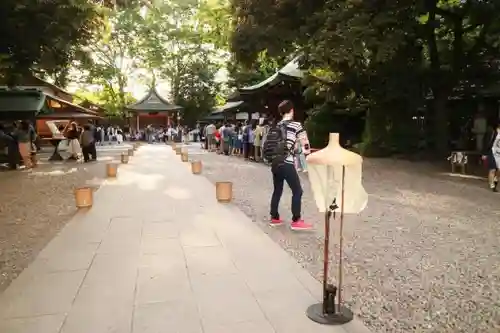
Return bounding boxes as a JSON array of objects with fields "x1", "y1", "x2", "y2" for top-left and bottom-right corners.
[{"x1": 0, "y1": 0, "x2": 230, "y2": 121}]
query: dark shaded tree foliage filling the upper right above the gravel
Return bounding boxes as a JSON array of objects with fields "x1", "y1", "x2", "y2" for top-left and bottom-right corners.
[{"x1": 232, "y1": 0, "x2": 500, "y2": 153}]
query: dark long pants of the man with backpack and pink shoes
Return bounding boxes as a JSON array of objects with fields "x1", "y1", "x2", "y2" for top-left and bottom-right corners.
[{"x1": 271, "y1": 163, "x2": 302, "y2": 222}]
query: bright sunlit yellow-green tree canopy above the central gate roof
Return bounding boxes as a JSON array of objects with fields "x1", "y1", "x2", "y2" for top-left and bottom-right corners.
[{"x1": 61, "y1": 1, "x2": 228, "y2": 122}]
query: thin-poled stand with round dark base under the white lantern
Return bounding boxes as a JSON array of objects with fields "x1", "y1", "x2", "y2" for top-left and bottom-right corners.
[{"x1": 306, "y1": 166, "x2": 354, "y2": 325}]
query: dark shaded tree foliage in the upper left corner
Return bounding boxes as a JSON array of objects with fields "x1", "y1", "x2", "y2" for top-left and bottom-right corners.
[{"x1": 0, "y1": 0, "x2": 102, "y2": 85}]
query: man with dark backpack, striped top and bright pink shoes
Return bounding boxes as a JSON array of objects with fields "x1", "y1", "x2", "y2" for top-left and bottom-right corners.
[{"x1": 262, "y1": 100, "x2": 312, "y2": 230}]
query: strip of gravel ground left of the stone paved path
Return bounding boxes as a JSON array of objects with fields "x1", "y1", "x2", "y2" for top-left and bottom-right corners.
[{"x1": 0, "y1": 146, "x2": 131, "y2": 292}]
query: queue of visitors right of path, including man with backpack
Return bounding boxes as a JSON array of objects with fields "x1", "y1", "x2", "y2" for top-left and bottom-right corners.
[{"x1": 202, "y1": 100, "x2": 312, "y2": 230}]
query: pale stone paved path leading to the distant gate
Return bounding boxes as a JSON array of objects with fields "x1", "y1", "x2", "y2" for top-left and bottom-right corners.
[{"x1": 0, "y1": 145, "x2": 367, "y2": 333}]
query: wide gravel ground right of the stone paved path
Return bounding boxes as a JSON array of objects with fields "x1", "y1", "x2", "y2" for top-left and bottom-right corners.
[{"x1": 190, "y1": 146, "x2": 500, "y2": 333}]
